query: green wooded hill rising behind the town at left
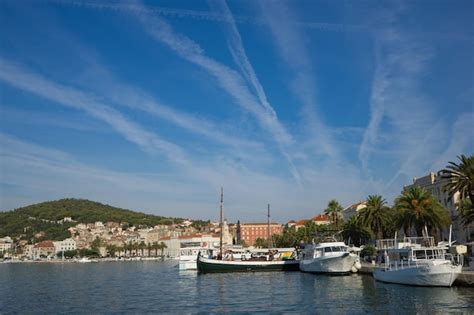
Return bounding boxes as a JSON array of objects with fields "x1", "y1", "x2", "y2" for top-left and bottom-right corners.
[{"x1": 0, "y1": 199, "x2": 183, "y2": 241}]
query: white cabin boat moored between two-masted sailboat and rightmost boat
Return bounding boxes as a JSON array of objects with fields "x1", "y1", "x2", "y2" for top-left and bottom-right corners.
[{"x1": 300, "y1": 242, "x2": 361, "y2": 274}]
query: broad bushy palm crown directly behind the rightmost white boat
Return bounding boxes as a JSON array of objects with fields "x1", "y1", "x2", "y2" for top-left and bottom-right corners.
[{"x1": 395, "y1": 186, "x2": 451, "y2": 235}]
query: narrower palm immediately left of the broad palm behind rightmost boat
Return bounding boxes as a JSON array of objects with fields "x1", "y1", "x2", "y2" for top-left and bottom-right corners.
[{"x1": 357, "y1": 195, "x2": 390, "y2": 239}]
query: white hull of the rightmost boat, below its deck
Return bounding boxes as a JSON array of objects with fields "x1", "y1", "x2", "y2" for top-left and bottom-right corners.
[{"x1": 373, "y1": 264, "x2": 462, "y2": 287}]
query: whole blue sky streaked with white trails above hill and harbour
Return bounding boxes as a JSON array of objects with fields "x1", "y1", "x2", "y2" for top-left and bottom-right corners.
[{"x1": 0, "y1": 0, "x2": 474, "y2": 222}]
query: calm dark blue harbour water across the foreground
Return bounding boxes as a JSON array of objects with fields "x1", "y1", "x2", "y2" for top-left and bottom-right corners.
[{"x1": 0, "y1": 262, "x2": 474, "y2": 314}]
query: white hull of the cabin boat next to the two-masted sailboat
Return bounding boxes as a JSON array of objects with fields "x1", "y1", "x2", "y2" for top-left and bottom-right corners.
[{"x1": 300, "y1": 253, "x2": 359, "y2": 274}]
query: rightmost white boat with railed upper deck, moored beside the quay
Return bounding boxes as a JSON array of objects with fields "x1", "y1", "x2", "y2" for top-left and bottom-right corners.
[{"x1": 373, "y1": 237, "x2": 464, "y2": 287}]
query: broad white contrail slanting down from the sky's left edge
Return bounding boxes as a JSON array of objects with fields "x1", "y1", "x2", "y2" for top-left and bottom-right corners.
[{"x1": 0, "y1": 59, "x2": 186, "y2": 163}]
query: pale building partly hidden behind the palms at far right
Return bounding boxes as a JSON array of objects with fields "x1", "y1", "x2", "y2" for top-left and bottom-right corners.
[{"x1": 404, "y1": 172, "x2": 474, "y2": 243}]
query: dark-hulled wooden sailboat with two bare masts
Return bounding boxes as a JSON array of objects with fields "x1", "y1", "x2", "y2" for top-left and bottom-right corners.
[{"x1": 197, "y1": 188, "x2": 299, "y2": 273}]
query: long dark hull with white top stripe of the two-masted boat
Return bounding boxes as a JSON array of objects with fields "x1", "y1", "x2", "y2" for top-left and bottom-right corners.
[{"x1": 196, "y1": 256, "x2": 299, "y2": 273}]
